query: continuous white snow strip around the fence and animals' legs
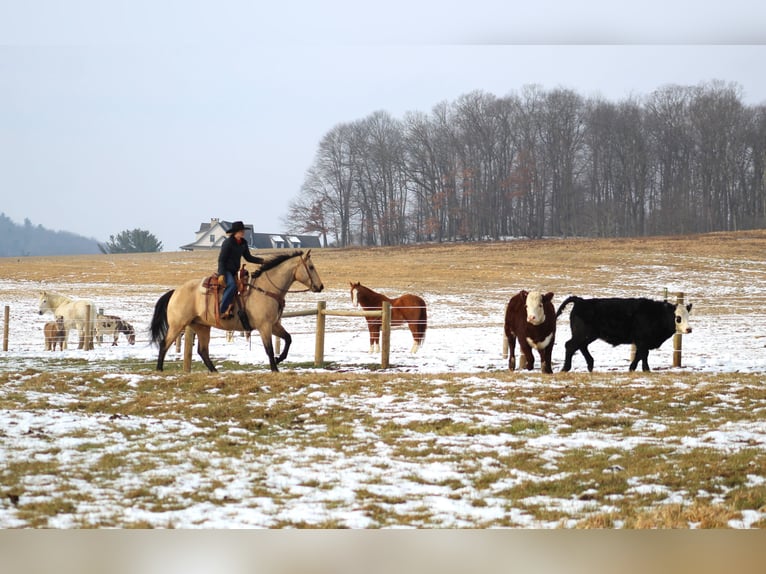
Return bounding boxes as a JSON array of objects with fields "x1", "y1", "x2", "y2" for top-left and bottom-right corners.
[{"x1": 0, "y1": 278, "x2": 766, "y2": 373}]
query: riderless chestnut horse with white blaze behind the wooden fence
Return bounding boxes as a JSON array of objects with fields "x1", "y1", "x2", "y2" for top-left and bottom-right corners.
[{"x1": 351, "y1": 283, "x2": 428, "y2": 353}]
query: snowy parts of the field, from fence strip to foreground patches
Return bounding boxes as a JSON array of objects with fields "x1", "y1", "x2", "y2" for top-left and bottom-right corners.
[{"x1": 0, "y1": 272, "x2": 766, "y2": 528}]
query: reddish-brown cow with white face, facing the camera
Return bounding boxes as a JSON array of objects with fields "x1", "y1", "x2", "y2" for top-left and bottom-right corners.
[{"x1": 505, "y1": 291, "x2": 556, "y2": 373}]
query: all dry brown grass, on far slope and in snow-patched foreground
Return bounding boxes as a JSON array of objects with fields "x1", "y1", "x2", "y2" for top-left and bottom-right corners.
[{"x1": 0, "y1": 231, "x2": 766, "y2": 528}]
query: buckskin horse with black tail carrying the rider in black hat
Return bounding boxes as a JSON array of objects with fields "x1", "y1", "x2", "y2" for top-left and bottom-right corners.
[{"x1": 150, "y1": 249, "x2": 324, "y2": 372}]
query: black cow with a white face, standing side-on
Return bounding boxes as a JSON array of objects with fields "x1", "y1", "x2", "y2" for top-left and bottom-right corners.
[{"x1": 556, "y1": 297, "x2": 692, "y2": 371}]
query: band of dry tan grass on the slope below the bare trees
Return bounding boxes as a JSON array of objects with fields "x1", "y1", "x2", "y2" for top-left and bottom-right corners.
[{"x1": 6, "y1": 230, "x2": 766, "y2": 293}]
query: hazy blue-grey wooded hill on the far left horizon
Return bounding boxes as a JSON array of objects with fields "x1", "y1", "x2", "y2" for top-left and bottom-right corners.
[{"x1": 0, "y1": 213, "x2": 101, "y2": 257}]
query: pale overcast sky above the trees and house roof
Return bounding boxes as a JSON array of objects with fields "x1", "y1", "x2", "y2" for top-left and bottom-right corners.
[{"x1": 0, "y1": 0, "x2": 766, "y2": 251}]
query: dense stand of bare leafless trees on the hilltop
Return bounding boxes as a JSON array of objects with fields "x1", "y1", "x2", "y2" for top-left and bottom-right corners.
[{"x1": 285, "y1": 81, "x2": 766, "y2": 246}]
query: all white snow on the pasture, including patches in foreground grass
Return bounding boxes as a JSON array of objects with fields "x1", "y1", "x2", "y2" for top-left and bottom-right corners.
[{"x1": 0, "y1": 274, "x2": 766, "y2": 528}]
